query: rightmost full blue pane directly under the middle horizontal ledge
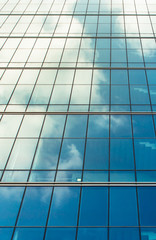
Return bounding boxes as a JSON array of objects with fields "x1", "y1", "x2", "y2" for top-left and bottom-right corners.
[{"x1": 132, "y1": 115, "x2": 155, "y2": 138}]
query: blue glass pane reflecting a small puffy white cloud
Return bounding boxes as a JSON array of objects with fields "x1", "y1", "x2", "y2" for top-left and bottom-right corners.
[{"x1": 59, "y1": 139, "x2": 85, "y2": 169}]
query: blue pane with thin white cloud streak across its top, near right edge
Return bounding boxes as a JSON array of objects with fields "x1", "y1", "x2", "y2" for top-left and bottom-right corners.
[{"x1": 130, "y1": 85, "x2": 150, "y2": 104}]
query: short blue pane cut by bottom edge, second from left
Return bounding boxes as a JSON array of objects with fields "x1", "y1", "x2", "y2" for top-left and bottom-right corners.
[{"x1": 13, "y1": 228, "x2": 44, "y2": 240}]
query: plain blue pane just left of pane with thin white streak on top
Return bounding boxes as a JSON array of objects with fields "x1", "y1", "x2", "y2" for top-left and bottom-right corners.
[{"x1": 111, "y1": 85, "x2": 129, "y2": 104}]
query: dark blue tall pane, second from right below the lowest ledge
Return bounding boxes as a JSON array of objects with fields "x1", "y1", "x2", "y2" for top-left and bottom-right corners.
[{"x1": 110, "y1": 187, "x2": 138, "y2": 226}]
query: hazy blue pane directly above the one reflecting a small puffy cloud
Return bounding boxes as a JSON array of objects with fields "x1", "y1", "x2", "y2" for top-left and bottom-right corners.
[{"x1": 65, "y1": 115, "x2": 87, "y2": 138}]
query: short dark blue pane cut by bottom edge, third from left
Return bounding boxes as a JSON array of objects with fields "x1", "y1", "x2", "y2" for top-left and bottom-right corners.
[{"x1": 45, "y1": 228, "x2": 76, "y2": 240}]
